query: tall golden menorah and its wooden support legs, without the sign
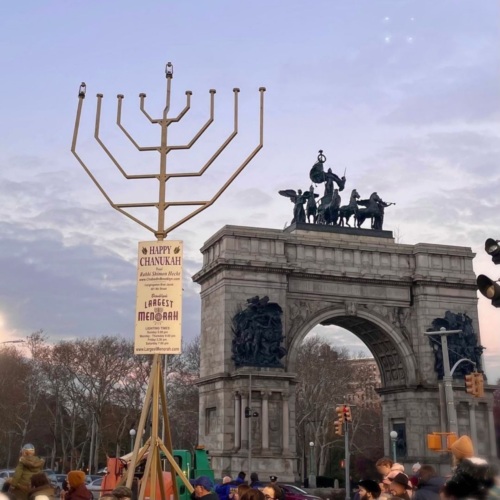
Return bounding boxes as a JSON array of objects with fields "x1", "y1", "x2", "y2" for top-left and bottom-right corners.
[{"x1": 71, "y1": 63, "x2": 266, "y2": 500}]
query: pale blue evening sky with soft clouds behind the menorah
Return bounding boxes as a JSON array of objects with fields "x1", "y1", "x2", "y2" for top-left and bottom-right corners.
[{"x1": 0, "y1": 0, "x2": 500, "y2": 381}]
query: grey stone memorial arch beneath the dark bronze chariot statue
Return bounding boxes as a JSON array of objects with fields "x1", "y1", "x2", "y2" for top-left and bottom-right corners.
[{"x1": 193, "y1": 223, "x2": 496, "y2": 481}]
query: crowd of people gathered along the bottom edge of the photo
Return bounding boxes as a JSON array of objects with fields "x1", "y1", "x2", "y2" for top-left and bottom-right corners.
[{"x1": 0, "y1": 435, "x2": 500, "y2": 500}]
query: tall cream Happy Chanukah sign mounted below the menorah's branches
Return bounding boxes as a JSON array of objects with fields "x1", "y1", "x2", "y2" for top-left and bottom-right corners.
[{"x1": 134, "y1": 241, "x2": 183, "y2": 354}]
